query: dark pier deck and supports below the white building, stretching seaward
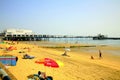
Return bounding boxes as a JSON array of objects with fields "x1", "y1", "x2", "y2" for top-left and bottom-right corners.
[{"x1": 2, "y1": 34, "x2": 91, "y2": 41}]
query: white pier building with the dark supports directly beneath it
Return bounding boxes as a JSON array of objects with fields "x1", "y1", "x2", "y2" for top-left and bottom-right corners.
[{"x1": 3, "y1": 29, "x2": 41, "y2": 41}]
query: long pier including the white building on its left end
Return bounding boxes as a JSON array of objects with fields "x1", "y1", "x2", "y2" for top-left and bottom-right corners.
[{"x1": 1, "y1": 29, "x2": 91, "y2": 41}]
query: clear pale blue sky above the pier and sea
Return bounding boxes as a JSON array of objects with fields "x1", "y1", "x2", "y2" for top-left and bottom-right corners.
[{"x1": 0, "y1": 0, "x2": 120, "y2": 37}]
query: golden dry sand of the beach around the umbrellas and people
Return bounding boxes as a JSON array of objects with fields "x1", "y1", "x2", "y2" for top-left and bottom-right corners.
[{"x1": 0, "y1": 43, "x2": 120, "y2": 80}]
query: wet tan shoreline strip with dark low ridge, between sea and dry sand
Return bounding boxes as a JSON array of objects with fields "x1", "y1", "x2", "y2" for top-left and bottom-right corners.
[{"x1": 22, "y1": 41, "x2": 120, "y2": 55}]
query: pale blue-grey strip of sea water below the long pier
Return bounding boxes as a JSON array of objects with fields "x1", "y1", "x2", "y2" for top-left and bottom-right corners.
[{"x1": 49, "y1": 38, "x2": 120, "y2": 46}]
